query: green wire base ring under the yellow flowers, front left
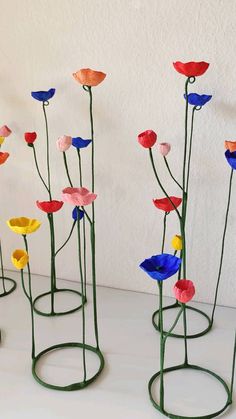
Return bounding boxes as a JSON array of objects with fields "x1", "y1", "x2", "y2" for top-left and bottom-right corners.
[{"x1": 32, "y1": 342, "x2": 105, "y2": 391}]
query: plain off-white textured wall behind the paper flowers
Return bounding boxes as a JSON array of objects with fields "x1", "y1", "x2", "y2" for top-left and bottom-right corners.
[{"x1": 0, "y1": 0, "x2": 236, "y2": 306}]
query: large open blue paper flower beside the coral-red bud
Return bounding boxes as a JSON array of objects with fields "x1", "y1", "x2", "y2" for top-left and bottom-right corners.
[{"x1": 139, "y1": 253, "x2": 181, "y2": 281}]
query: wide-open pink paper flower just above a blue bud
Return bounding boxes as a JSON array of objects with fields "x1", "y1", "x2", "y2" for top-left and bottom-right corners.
[{"x1": 62, "y1": 188, "x2": 97, "y2": 207}]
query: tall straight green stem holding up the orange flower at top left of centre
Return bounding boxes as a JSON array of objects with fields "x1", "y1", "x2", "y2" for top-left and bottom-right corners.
[{"x1": 84, "y1": 86, "x2": 99, "y2": 349}]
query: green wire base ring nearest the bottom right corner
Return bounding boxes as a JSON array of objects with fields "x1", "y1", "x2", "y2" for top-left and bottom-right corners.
[{"x1": 148, "y1": 364, "x2": 232, "y2": 419}]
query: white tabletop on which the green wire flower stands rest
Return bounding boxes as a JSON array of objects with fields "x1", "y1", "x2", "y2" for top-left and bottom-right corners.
[{"x1": 0, "y1": 273, "x2": 236, "y2": 419}]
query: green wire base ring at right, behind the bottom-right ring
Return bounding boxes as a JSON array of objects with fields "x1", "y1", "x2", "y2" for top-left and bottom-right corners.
[{"x1": 152, "y1": 302, "x2": 213, "y2": 339}]
